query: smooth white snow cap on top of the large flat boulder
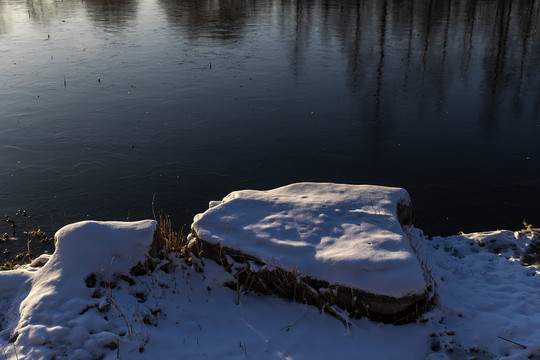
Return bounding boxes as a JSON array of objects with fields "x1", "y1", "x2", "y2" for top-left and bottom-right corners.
[{"x1": 192, "y1": 183, "x2": 426, "y2": 298}]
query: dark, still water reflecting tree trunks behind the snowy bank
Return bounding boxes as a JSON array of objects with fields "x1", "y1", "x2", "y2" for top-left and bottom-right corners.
[{"x1": 0, "y1": 0, "x2": 540, "y2": 260}]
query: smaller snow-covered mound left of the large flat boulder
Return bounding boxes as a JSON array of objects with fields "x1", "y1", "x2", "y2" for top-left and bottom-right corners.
[{"x1": 0, "y1": 220, "x2": 155, "y2": 359}]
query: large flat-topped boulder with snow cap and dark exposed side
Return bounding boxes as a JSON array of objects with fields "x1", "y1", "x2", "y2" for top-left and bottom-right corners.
[{"x1": 190, "y1": 183, "x2": 429, "y2": 323}]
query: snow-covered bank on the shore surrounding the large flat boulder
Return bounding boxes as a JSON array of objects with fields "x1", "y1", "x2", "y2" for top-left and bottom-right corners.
[{"x1": 0, "y1": 195, "x2": 540, "y2": 360}]
